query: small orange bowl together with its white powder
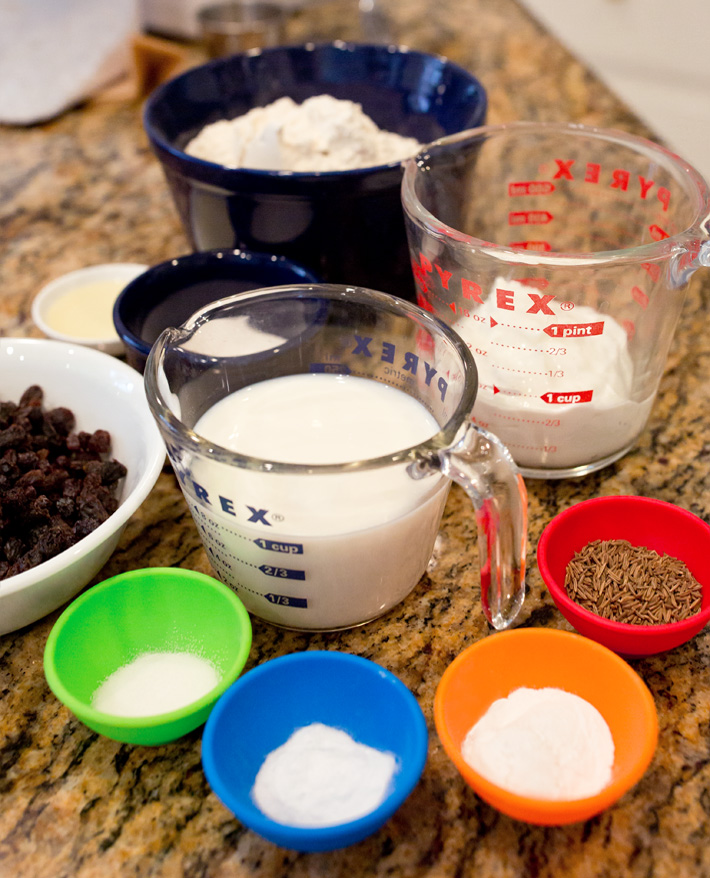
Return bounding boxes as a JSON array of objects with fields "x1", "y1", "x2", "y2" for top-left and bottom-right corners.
[{"x1": 434, "y1": 628, "x2": 658, "y2": 826}]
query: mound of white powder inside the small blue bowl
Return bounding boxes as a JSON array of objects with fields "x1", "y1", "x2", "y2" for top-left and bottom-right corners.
[{"x1": 252, "y1": 723, "x2": 397, "y2": 827}]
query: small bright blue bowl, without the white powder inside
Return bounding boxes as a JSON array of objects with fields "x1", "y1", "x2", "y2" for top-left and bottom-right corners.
[{"x1": 202, "y1": 651, "x2": 428, "y2": 851}]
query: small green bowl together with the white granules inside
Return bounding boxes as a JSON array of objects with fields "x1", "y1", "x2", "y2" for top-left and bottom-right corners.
[{"x1": 44, "y1": 567, "x2": 251, "y2": 744}]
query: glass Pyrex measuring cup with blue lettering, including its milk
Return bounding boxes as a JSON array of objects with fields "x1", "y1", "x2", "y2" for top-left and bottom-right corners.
[{"x1": 145, "y1": 285, "x2": 527, "y2": 630}]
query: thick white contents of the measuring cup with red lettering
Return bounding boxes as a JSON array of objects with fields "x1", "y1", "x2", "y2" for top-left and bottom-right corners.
[{"x1": 453, "y1": 278, "x2": 653, "y2": 468}]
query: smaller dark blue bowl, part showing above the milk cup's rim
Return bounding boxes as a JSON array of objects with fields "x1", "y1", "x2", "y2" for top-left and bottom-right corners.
[{"x1": 113, "y1": 250, "x2": 320, "y2": 373}]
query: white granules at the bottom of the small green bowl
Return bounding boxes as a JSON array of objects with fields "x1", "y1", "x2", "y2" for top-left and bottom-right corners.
[{"x1": 91, "y1": 652, "x2": 219, "y2": 716}]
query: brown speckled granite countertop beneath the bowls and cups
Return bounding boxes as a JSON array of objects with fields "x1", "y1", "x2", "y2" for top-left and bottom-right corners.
[{"x1": 0, "y1": 0, "x2": 710, "y2": 878}]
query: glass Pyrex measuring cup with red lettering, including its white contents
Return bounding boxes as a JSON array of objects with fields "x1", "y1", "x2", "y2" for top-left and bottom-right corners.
[{"x1": 402, "y1": 122, "x2": 710, "y2": 478}]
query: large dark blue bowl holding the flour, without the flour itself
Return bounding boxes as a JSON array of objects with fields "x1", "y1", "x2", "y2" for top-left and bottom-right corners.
[{"x1": 144, "y1": 42, "x2": 487, "y2": 300}]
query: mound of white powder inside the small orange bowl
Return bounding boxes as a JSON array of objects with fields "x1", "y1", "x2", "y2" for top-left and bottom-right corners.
[{"x1": 461, "y1": 687, "x2": 614, "y2": 799}]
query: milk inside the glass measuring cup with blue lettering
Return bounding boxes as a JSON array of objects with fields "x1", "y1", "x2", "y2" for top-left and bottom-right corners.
[{"x1": 186, "y1": 373, "x2": 449, "y2": 630}]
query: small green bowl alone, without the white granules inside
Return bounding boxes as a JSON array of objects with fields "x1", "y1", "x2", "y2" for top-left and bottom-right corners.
[{"x1": 44, "y1": 567, "x2": 251, "y2": 745}]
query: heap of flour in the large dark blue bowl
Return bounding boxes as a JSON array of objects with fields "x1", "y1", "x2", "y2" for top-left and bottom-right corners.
[{"x1": 185, "y1": 95, "x2": 426, "y2": 171}]
